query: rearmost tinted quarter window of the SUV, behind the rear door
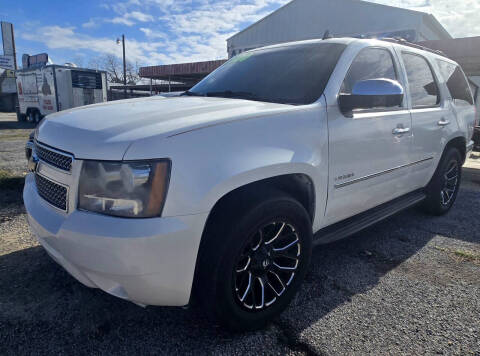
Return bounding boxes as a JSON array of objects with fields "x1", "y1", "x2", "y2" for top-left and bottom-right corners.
[{"x1": 437, "y1": 60, "x2": 473, "y2": 105}]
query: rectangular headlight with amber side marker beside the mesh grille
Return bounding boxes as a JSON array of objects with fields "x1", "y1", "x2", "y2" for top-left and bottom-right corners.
[{"x1": 78, "y1": 160, "x2": 170, "y2": 218}]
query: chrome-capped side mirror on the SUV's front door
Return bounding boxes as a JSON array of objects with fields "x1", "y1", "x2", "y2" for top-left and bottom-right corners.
[{"x1": 338, "y1": 78, "x2": 404, "y2": 113}]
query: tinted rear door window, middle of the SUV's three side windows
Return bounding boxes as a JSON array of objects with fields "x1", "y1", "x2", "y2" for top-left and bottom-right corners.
[{"x1": 402, "y1": 53, "x2": 440, "y2": 108}]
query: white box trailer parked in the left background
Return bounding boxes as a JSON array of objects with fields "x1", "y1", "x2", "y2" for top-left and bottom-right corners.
[{"x1": 17, "y1": 65, "x2": 107, "y2": 122}]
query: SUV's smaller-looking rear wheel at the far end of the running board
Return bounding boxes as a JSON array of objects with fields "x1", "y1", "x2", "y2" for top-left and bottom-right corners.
[{"x1": 423, "y1": 148, "x2": 462, "y2": 215}]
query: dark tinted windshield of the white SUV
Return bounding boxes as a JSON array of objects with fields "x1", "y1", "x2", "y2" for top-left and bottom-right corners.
[{"x1": 186, "y1": 43, "x2": 346, "y2": 105}]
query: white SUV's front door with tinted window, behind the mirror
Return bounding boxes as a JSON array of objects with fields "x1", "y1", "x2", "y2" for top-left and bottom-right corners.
[{"x1": 325, "y1": 47, "x2": 412, "y2": 225}]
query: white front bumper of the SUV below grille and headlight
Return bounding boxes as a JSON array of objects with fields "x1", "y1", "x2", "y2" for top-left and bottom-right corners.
[{"x1": 23, "y1": 174, "x2": 208, "y2": 306}]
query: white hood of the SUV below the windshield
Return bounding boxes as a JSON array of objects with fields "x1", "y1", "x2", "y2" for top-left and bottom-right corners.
[{"x1": 36, "y1": 96, "x2": 293, "y2": 160}]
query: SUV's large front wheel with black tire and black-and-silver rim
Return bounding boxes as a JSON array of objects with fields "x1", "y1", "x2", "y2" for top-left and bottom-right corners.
[{"x1": 195, "y1": 192, "x2": 312, "y2": 331}]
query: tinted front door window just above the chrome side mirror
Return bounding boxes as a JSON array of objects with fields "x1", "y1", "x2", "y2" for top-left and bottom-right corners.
[{"x1": 341, "y1": 48, "x2": 397, "y2": 94}]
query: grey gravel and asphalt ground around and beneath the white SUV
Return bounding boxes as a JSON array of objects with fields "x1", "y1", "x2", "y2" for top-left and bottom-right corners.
[{"x1": 0, "y1": 114, "x2": 480, "y2": 355}]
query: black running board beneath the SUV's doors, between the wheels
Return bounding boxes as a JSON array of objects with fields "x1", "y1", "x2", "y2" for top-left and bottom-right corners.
[{"x1": 313, "y1": 190, "x2": 426, "y2": 245}]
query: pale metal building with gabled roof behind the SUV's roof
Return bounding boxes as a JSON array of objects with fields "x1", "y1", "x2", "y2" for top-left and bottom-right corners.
[{"x1": 227, "y1": 0, "x2": 452, "y2": 58}]
